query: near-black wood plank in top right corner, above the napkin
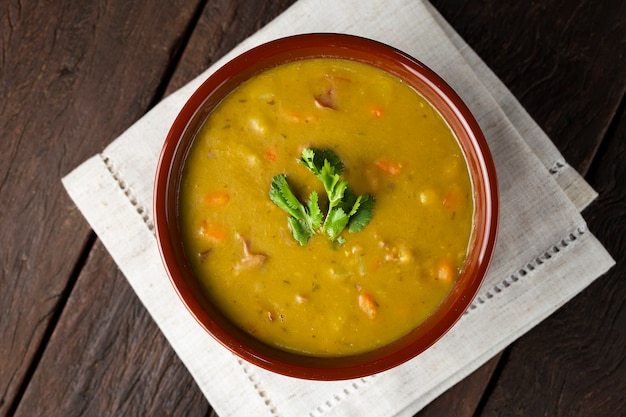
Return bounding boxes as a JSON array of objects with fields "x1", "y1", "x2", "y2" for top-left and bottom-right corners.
[{"x1": 431, "y1": 0, "x2": 626, "y2": 173}]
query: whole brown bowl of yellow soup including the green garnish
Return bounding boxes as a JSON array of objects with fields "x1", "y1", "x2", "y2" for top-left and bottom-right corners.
[{"x1": 154, "y1": 34, "x2": 498, "y2": 380}]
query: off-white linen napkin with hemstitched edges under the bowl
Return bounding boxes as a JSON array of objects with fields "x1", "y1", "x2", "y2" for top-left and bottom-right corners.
[{"x1": 63, "y1": 0, "x2": 614, "y2": 417}]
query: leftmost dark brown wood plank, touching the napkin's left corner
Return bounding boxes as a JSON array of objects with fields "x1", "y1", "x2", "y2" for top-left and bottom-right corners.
[{"x1": 0, "y1": 0, "x2": 201, "y2": 416}]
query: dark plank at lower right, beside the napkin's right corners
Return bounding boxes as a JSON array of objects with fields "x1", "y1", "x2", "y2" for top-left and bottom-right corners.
[{"x1": 481, "y1": 101, "x2": 626, "y2": 417}]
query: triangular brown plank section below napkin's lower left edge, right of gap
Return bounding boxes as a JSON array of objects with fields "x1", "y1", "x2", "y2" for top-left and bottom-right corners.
[{"x1": 15, "y1": 241, "x2": 209, "y2": 417}]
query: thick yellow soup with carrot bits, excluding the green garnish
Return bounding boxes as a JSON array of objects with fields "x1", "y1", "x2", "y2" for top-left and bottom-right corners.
[{"x1": 179, "y1": 59, "x2": 474, "y2": 356}]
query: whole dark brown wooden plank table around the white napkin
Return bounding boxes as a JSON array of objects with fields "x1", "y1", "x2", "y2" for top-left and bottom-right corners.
[{"x1": 0, "y1": 0, "x2": 626, "y2": 417}]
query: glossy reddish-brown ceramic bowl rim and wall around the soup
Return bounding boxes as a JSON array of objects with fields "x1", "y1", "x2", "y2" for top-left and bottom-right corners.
[{"x1": 154, "y1": 34, "x2": 498, "y2": 380}]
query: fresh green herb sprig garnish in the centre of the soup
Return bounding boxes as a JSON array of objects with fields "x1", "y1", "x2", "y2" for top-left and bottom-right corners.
[{"x1": 270, "y1": 149, "x2": 375, "y2": 246}]
